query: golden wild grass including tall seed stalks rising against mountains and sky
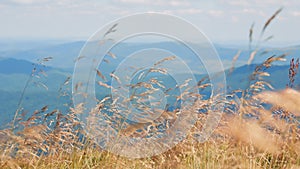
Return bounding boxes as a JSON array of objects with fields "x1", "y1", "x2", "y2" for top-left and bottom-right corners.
[{"x1": 0, "y1": 9, "x2": 300, "y2": 169}]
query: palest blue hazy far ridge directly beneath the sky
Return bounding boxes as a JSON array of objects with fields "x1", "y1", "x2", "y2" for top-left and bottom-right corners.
[{"x1": 0, "y1": 41, "x2": 300, "y2": 70}]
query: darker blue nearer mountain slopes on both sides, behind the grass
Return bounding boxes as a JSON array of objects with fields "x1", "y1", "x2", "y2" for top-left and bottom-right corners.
[{"x1": 0, "y1": 55, "x2": 300, "y2": 126}]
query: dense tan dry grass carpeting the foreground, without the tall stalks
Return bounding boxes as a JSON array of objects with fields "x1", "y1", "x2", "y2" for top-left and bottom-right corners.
[{"x1": 0, "y1": 63, "x2": 300, "y2": 168}]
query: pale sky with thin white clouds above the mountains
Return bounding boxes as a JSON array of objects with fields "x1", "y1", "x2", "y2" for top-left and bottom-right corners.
[{"x1": 0, "y1": 0, "x2": 300, "y2": 45}]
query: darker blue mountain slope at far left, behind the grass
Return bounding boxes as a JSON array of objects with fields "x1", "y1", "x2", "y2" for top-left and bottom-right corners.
[{"x1": 0, "y1": 58, "x2": 71, "y2": 127}]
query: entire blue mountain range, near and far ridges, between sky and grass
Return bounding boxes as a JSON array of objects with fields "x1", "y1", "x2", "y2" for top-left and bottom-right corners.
[{"x1": 0, "y1": 42, "x2": 300, "y2": 127}]
